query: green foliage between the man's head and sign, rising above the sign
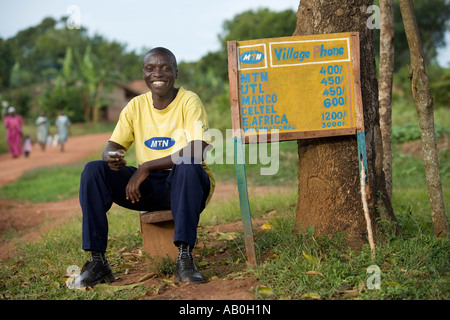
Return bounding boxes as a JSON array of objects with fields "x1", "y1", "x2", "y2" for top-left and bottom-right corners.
[{"x1": 178, "y1": 9, "x2": 296, "y2": 131}]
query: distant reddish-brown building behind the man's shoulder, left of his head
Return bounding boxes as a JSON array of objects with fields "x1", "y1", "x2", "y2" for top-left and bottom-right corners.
[{"x1": 100, "y1": 80, "x2": 149, "y2": 122}]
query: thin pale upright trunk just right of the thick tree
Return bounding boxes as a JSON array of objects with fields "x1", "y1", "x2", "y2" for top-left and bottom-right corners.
[{"x1": 378, "y1": 0, "x2": 394, "y2": 201}]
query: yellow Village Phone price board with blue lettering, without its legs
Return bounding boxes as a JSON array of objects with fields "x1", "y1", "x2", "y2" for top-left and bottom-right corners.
[{"x1": 228, "y1": 32, "x2": 364, "y2": 142}]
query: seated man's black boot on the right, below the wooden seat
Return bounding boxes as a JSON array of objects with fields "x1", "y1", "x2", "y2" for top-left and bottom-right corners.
[{"x1": 174, "y1": 243, "x2": 205, "y2": 283}]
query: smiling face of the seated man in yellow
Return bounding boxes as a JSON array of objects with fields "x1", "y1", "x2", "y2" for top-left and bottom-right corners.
[{"x1": 143, "y1": 51, "x2": 178, "y2": 98}]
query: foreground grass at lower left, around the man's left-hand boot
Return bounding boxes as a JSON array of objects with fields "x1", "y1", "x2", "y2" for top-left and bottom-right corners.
[{"x1": 0, "y1": 208, "x2": 148, "y2": 300}]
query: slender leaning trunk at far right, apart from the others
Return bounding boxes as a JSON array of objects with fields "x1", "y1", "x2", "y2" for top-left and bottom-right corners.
[{"x1": 400, "y1": 0, "x2": 448, "y2": 236}]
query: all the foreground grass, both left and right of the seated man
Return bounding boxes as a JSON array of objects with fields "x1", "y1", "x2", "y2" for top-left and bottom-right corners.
[{"x1": 0, "y1": 186, "x2": 450, "y2": 300}]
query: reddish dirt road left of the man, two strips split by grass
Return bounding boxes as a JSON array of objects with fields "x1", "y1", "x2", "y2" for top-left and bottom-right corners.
[{"x1": 0, "y1": 133, "x2": 110, "y2": 260}]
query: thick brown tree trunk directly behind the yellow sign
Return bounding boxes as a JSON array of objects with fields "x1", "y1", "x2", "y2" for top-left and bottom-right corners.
[{"x1": 294, "y1": 0, "x2": 395, "y2": 249}]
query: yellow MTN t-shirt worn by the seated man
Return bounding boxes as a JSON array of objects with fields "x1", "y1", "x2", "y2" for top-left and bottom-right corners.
[{"x1": 110, "y1": 87, "x2": 216, "y2": 203}]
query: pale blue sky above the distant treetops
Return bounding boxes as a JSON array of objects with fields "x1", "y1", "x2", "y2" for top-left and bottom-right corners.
[{"x1": 0, "y1": 0, "x2": 450, "y2": 66}]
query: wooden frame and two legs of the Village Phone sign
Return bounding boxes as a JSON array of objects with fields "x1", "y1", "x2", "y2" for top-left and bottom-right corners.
[{"x1": 227, "y1": 32, "x2": 371, "y2": 266}]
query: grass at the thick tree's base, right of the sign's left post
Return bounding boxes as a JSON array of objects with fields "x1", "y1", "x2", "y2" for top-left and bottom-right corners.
[{"x1": 251, "y1": 212, "x2": 450, "y2": 300}]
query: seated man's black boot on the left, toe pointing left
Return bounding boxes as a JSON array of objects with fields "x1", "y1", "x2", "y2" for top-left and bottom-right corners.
[{"x1": 74, "y1": 251, "x2": 115, "y2": 287}]
